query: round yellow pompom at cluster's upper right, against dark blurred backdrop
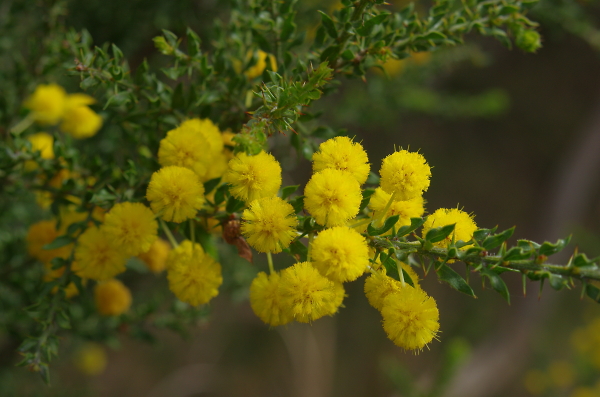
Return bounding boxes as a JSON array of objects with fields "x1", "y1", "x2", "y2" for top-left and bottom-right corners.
[{"x1": 379, "y1": 150, "x2": 431, "y2": 201}]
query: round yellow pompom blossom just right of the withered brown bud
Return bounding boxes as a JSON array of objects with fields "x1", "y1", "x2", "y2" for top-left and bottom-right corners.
[{"x1": 242, "y1": 196, "x2": 298, "y2": 253}]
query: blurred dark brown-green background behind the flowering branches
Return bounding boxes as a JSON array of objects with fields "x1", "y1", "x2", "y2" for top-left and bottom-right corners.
[{"x1": 0, "y1": 0, "x2": 600, "y2": 397}]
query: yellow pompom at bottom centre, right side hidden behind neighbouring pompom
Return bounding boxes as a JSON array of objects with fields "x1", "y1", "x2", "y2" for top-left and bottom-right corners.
[{"x1": 250, "y1": 272, "x2": 294, "y2": 327}]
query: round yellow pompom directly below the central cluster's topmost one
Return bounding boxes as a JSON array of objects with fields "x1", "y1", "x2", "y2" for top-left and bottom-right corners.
[{"x1": 304, "y1": 168, "x2": 362, "y2": 227}]
